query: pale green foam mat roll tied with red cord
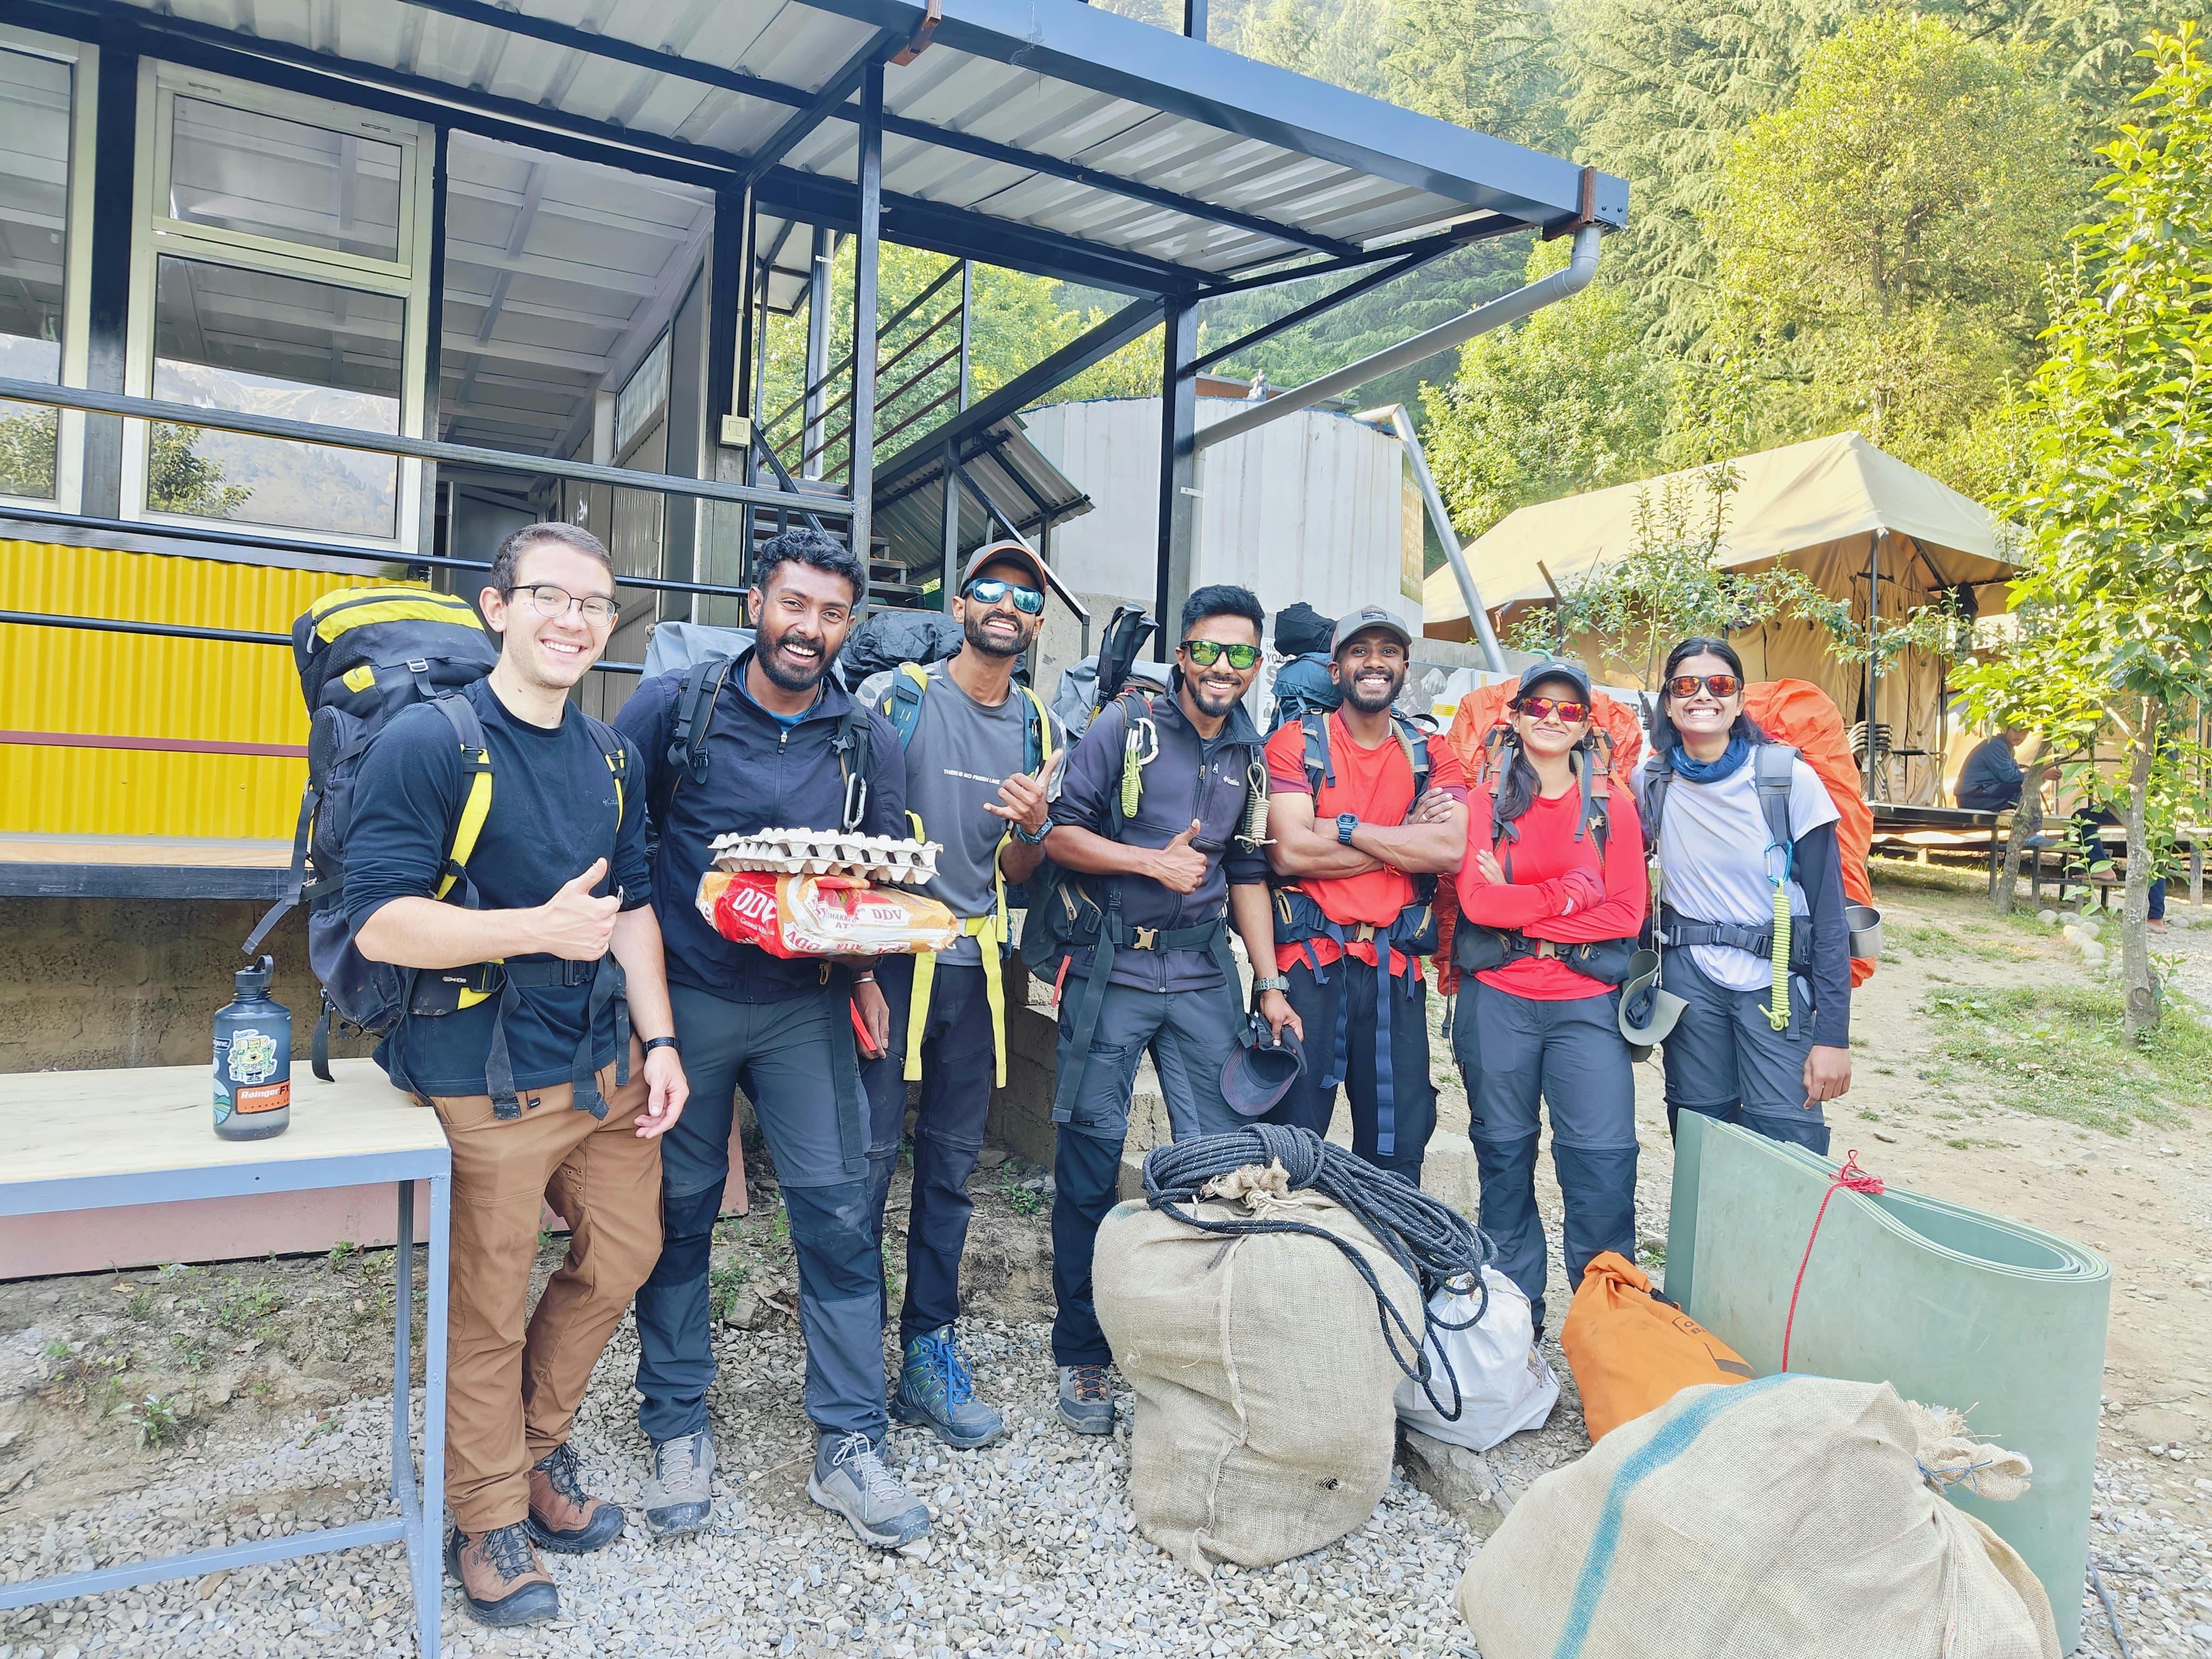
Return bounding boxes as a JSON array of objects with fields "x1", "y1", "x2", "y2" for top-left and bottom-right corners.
[{"x1": 1665, "y1": 1112, "x2": 2113, "y2": 1653}]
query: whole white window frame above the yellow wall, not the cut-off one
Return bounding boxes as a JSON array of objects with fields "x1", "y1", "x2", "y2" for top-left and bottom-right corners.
[{"x1": 122, "y1": 60, "x2": 438, "y2": 555}]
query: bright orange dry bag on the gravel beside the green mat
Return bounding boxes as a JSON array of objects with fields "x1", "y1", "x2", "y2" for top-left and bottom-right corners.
[{"x1": 1560, "y1": 1250, "x2": 1752, "y2": 1442}]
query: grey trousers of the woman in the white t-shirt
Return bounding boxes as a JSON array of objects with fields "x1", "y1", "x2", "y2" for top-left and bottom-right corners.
[{"x1": 1663, "y1": 951, "x2": 1827, "y2": 1157}]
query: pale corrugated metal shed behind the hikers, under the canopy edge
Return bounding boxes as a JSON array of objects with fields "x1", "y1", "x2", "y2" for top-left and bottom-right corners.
[{"x1": 1024, "y1": 398, "x2": 1420, "y2": 635}]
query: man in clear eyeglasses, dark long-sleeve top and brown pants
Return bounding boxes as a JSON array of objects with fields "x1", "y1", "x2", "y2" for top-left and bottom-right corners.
[{"x1": 345, "y1": 524, "x2": 688, "y2": 1626}]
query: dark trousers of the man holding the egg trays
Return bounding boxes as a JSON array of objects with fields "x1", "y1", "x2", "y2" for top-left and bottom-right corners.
[{"x1": 637, "y1": 975, "x2": 885, "y2": 1440}]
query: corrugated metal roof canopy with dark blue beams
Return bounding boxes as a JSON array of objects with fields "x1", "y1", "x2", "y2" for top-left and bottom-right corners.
[{"x1": 102, "y1": 0, "x2": 1628, "y2": 299}]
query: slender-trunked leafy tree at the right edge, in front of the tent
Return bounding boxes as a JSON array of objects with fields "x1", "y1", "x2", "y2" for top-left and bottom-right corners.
[{"x1": 1960, "y1": 26, "x2": 2212, "y2": 1037}]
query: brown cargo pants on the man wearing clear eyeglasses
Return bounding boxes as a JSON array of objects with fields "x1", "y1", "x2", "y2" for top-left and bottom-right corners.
[{"x1": 431, "y1": 1042, "x2": 662, "y2": 1535}]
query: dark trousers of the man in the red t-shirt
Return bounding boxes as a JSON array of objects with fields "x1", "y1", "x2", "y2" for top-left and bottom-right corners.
[{"x1": 1261, "y1": 955, "x2": 1435, "y2": 1185}]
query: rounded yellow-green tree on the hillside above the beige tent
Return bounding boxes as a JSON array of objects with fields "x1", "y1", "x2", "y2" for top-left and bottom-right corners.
[{"x1": 1708, "y1": 11, "x2": 2081, "y2": 477}]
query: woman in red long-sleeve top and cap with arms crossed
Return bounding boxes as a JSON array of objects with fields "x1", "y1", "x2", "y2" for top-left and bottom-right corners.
[{"x1": 1451, "y1": 662, "x2": 1648, "y2": 1332}]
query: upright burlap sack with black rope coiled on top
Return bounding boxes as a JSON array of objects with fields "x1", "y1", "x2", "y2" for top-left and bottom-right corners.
[{"x1": 1090, "y1": 1166, "x2": 1422, "y2": 1573}]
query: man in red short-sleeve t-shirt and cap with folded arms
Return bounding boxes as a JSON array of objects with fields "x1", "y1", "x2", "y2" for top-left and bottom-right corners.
[{"x1": 1265, "y1": 606, "x2": 1467, "y2": 1185}]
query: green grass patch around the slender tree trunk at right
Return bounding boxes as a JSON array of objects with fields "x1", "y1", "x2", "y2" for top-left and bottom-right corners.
[{"x1": 1920, "y1": 984, "x2": 2212, "y2": 1135}]
